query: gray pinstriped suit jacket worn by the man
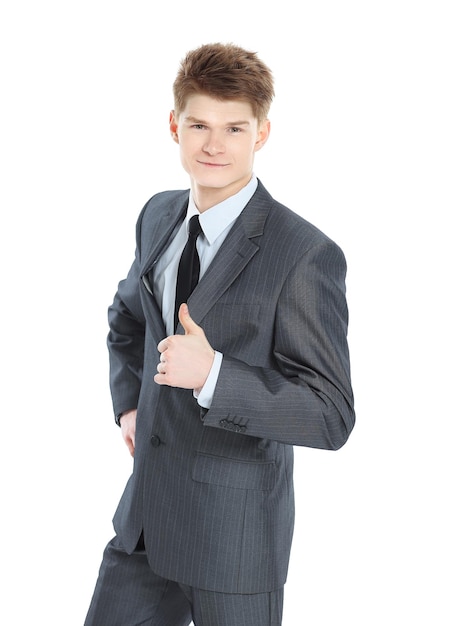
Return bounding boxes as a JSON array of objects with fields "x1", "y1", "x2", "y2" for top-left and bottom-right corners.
[{"x1": 108, "y1": 181, "x2": 355, "y2": 593}]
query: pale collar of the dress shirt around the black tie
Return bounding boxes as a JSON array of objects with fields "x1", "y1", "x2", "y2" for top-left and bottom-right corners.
[{"x1": 186, "y1": 174, "x2": 258, "y2": 245}]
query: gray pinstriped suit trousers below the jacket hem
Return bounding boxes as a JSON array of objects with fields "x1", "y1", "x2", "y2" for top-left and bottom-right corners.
[{"x1": 84, "y1": 537, "x2": 283, "y2": 626}]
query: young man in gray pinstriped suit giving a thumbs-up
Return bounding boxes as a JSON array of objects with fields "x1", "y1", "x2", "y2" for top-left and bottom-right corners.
[{"x1": 86, "y1": 44, "x2": 355, "y2": 626}]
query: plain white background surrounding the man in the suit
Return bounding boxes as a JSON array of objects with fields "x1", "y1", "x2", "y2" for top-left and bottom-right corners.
[{"x1": 0, "y1": 0, "x2": 465, "y2": 626}]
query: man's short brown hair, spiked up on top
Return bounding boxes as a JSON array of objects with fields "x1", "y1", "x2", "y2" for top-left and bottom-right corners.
[{"x1": 173, "y1": 43, "x2": 274, "y2": 122}]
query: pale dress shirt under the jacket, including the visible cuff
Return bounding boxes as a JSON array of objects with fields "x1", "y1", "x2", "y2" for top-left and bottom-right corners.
[{"x1": 153, "y1": 175, "x2": 258, "y2": 409}]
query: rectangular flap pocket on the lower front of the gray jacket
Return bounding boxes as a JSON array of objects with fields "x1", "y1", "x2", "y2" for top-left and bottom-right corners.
[{"x1": 192, "y1": 452, "x2": 276, "y2": 491}]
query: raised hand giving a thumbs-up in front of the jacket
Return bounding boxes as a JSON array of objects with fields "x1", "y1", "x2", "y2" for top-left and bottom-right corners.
[{"x1": 154, "y1": 304, "x2": 215, "y2": 392}]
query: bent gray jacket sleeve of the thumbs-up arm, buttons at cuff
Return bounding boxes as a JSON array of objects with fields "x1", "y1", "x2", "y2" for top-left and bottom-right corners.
[{"x1": 203, "y1": 241, "x2": 355, "y2": 450}]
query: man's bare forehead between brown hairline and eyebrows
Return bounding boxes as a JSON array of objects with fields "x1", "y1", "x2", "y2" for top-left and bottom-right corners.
[{"x1": 180, "y1": 94, "x2": 255, "y2": 123}]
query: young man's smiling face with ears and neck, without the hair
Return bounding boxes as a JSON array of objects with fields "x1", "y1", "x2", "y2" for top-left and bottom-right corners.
[{"x1": 170, "y1": 94, "x2": 270, "y2": 211}]
